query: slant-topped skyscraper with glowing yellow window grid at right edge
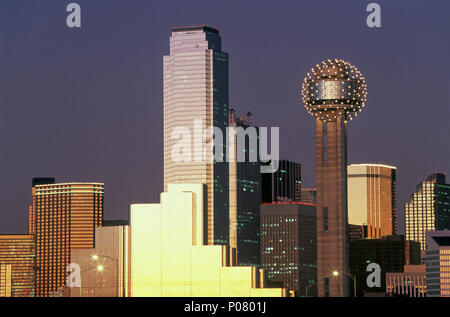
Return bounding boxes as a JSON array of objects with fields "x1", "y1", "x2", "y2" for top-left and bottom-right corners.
[{"x1": 405, "y1": 173, "x2": 450, "y2": 250}]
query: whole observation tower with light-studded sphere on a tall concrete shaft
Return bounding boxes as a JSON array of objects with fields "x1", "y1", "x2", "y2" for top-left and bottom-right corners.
[{"x1": 302, "y1": 59, "x2": 367, "y2": 297}]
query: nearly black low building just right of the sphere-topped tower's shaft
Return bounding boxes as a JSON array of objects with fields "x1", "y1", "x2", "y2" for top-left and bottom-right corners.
[{"x1": 349, "y1": 235, "x2": 420, "y2": 296}]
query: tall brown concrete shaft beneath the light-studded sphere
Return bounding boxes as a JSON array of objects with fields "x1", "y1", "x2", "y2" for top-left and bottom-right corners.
[{"x1": 316, "y1": 114, "x2": 349, "y2": 297}]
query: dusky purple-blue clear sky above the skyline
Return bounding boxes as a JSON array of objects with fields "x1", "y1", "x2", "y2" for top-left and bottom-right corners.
[{"x1": 0, "y1": 0, "x2": 450, "y2": 233}]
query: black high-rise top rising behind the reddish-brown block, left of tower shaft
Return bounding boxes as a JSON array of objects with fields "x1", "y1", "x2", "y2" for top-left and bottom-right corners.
[{"x1": 261, "y1": 160, "x2": 302, "y2": 203}]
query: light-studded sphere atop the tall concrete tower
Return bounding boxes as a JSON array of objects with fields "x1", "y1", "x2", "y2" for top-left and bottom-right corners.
[{"x1": 302, "y1": 59, "x2": 367, "y2": 122}]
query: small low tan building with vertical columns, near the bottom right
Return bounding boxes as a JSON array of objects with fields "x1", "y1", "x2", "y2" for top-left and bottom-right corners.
[{"x1": 386, "y1": 264, "x2": 427, "y2": 297}]
